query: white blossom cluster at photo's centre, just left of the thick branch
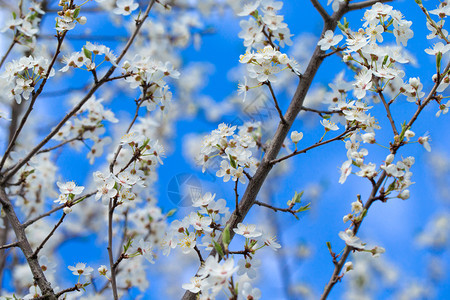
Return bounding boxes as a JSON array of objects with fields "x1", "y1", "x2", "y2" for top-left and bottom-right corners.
[{"x1": 197, "y1": 122, "x2": 261, "y2": 183}]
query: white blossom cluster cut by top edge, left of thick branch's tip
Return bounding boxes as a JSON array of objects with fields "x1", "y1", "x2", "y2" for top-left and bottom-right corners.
[{"x1": 237, "y1": 0, "x2": 292, "y2": 50}]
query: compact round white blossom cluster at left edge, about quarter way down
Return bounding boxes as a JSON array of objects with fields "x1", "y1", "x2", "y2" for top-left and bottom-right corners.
[{"x1": 2, "y1": 56, "x2": 55, "y2": 104}]
